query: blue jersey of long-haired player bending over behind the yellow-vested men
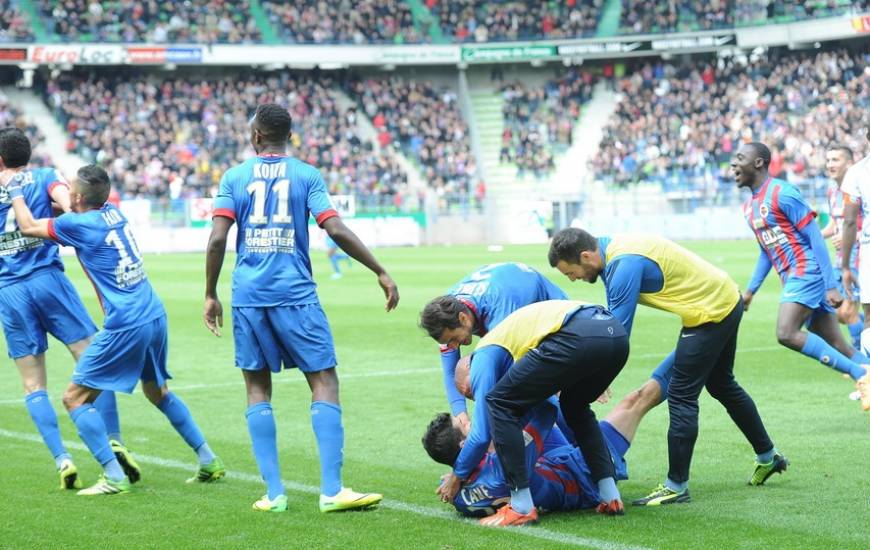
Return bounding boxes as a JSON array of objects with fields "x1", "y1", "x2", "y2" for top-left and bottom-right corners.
[{"x1": 441, "y1": 263, "x2": 568, "y2": 414}]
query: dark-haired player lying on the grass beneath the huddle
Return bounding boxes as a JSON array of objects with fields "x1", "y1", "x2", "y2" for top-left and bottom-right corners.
[{"x1": 423, "y1": 363, "x2": 670, "y2": 517}]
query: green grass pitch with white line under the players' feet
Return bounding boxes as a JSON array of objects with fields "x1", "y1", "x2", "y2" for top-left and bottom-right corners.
[{"x1": 0, "y1": 241, "x2": 870, "y2": 548}]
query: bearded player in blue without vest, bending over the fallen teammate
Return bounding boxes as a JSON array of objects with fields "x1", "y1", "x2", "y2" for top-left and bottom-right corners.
[{"x1": 420, "y1": 262, "x2": 568, "y2": 434}]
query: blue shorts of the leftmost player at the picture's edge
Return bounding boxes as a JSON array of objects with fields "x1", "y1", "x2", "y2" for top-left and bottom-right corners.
[{"x1": 0, "y1": 269, "x2": 97, "y2": 359}]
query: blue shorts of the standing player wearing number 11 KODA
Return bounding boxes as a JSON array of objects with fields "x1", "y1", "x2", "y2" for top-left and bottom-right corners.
[{"x1": 233, "y1": 303, "x2": 337, "y2": 372}]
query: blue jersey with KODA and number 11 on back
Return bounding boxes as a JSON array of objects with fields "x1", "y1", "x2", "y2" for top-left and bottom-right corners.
[{"x1": 214, "y1": 155, "x2": 338, "y2": 307}]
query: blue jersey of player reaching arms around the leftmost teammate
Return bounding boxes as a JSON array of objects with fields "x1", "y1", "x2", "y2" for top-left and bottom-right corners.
[{"x1": 48, "y1": 203, "x2": 166, "y2": 330}]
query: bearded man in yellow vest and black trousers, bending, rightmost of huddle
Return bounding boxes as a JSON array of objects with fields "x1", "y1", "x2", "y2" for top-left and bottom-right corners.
[{"x1": 549, "y1": 228, "x2": 788, "y2": 506}]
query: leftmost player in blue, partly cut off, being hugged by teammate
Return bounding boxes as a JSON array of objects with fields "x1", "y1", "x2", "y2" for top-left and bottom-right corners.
[{"x1": 0, "y1": 127, "x2": 139, "y2": 489}]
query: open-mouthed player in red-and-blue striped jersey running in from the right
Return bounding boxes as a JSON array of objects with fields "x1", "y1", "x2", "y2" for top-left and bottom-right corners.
[{"x1": 731, "y1": 142, "x2": 870, "y2": 410}]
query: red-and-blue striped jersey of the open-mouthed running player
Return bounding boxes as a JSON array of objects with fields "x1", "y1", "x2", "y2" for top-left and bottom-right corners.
[{"x1": 743, "y1": 178, "x2": 823, "y2": 283}]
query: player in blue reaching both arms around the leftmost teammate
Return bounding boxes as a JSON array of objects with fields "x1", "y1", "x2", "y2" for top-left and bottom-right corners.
[{"x1": 6, "y1": 165, "x2": 225, "y2": 495}]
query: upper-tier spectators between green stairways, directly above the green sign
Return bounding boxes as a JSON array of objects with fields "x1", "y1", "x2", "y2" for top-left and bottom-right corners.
[{"x1": 425, "y1": 0, "x2": 604, "y2": 42}]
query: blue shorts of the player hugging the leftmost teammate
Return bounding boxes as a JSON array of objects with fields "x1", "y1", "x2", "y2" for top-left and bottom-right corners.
[{"x1": 72, "y1": 315, "x2": 172, "y2": 393}]
